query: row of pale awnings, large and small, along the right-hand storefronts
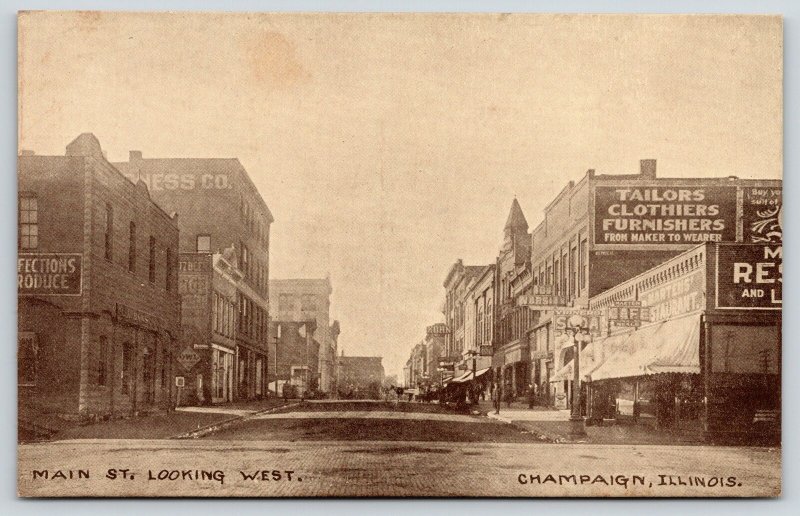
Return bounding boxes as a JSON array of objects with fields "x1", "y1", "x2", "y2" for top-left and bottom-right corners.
[{"x1": 551, "y1": 314, "x2": 700, "y2": 381}]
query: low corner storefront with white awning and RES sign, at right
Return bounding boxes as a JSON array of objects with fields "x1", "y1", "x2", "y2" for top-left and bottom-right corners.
[{"x1": 580, "y1": 244, "x2": 782, "y2": 441}]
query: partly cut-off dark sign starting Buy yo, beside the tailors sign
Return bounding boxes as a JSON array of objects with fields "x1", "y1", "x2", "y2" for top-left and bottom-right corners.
[{"x1": 742, "y1": 187, "x2": 783, "y2": 244}]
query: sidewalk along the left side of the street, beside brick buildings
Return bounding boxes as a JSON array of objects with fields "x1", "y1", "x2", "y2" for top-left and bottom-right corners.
[{"x1": 20, "y1": 398, "x2": 286, "y2": 441}]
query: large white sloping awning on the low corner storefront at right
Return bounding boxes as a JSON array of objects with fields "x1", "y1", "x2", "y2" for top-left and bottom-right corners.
[{"x1": 590, "y1": 314, "x2": 700, "y2": 381}]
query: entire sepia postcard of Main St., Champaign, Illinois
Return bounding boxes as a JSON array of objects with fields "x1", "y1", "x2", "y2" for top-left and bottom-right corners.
[{"x1": 17, "y1": 11, "x2": 783, "y2": 498}]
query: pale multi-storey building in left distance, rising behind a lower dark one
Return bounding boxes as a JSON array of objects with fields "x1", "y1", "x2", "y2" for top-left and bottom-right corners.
[{"x1": 270, "y1": 278, "x2": 340, "y2": 394}]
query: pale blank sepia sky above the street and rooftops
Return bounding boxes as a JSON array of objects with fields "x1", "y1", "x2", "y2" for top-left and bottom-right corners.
[{"x1": 19, "y1": 13, "x2": 782, "y2": 377}]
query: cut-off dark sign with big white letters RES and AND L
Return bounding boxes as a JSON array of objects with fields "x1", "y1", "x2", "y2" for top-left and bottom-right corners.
[{"x1": 715, "y1": 244, "x2": 783, "y2": 310}]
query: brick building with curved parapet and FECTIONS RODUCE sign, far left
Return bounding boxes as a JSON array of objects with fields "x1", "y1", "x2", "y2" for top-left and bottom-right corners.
[{"x1": 17, "y1": 133, "x2": 180, "y2": 420}]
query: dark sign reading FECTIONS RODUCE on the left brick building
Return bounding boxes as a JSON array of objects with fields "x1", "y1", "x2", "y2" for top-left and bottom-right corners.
[{"x1": 17, "y1": 253, "x2": 83, "y2": 296}]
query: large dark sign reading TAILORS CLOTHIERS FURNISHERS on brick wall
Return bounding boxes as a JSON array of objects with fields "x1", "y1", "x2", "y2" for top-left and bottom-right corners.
[{"x1": 594, "y1": 185, "x2": 736, "y2": 246}]
